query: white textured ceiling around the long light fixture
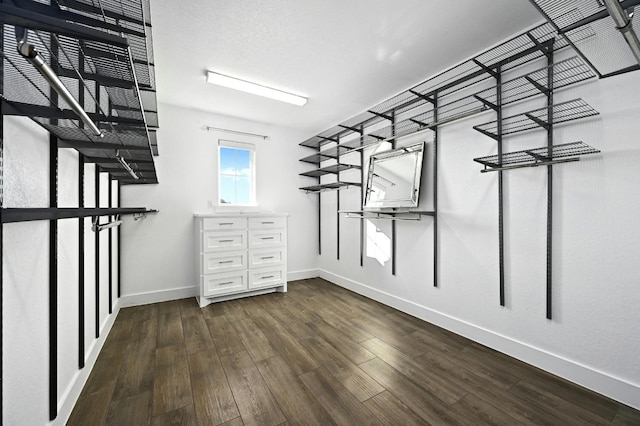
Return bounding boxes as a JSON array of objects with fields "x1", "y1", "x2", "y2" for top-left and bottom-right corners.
[{"x1": 151, "y1": 0, "x2": 542, "y2": 135}]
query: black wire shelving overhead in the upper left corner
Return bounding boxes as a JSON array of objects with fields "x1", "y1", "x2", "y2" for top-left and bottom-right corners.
[{"x1": 0, "y1": 0, "x2": 158, "y2": 184}]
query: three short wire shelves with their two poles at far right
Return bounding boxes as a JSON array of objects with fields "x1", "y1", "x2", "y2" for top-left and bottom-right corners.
[{"x1": 473, "y1": 32, "x2": 598, "y2": 319}]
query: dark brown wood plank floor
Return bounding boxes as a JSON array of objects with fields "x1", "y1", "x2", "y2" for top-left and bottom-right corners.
[{"x1": 68, "y1": 279, "x2": 640, "y2": 426}]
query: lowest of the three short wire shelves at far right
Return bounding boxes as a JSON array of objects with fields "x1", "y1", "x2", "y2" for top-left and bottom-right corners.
[{"x1": 473, "y1": 141, "x2": 600, "y2": 169}]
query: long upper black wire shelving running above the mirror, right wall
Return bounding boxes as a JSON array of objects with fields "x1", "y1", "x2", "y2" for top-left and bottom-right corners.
[{"x1": 300, "y1": 24, "x2": 596, "y2": 197}]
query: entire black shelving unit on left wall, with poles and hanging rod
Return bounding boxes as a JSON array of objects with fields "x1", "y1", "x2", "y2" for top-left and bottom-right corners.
[{"x1": 0, "y1": 0, "x2": 158, "y2": 420}]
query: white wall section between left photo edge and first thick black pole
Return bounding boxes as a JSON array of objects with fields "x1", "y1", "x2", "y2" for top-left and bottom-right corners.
[{"x1": 2, "y1": 117, "x2": 49, "y2": 425}]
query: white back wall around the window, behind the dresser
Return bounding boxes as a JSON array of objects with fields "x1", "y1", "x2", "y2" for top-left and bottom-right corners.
[{"x1": 121, "y1": 104, "x2": 318, "y2": 305}]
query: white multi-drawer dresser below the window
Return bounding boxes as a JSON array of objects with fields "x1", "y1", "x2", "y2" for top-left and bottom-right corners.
[{"x1": 194, "y1": 213, "x2": 287, "y2": 307}]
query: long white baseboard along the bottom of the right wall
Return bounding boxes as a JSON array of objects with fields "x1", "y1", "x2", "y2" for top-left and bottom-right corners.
[{"x1": 319, "y1": 269, "x2": 640, "y2": 409}]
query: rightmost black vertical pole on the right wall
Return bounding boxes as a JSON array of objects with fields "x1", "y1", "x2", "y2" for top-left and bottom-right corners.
[{"x1": 547, "y1": 45, "x2": 554, "y2": 319}]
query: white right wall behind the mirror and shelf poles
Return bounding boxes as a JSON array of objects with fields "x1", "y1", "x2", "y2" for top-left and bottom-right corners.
[{"x1": 321, "y1": 62, "x2": 640, "y2": 408}]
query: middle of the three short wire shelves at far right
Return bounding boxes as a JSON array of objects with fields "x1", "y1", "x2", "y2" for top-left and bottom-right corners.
[{"x1": 473, "y1": 99, "x2": 599, "y2": 139}]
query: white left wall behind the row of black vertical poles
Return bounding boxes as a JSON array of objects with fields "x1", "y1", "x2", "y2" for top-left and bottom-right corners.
[{"x1": 2, "y1": 117, "x2": 118, "y2": 425}]
